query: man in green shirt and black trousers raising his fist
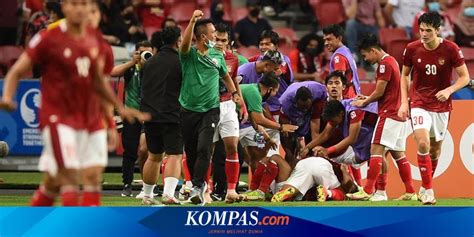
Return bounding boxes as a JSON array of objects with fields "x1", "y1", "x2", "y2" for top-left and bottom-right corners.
[{"x1": 179, "y1": 10, "x2": 240, "y2": 204}]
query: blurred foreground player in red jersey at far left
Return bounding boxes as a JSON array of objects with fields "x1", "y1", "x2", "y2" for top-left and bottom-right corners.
[{"x1": 0, "y1": 0, "x2": 147, "y2": 206}]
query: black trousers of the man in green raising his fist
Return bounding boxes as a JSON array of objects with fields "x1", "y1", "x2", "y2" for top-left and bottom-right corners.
[{"x1": 181, "y1": 108, "x2": 219, "y2": 187}]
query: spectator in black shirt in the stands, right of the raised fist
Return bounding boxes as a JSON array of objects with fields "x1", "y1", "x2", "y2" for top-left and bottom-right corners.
[{"x1": 235, "y1": 0, "x2": 272, "y2": 47}]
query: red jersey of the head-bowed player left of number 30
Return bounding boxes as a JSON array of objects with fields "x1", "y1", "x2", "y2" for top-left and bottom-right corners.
[{"x1": 376, "y1": 54, "x2": 402, "y2": 121}]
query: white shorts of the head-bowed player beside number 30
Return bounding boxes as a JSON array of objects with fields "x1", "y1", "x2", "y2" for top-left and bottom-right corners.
[{"x1": 372, "y1": 117, "x2": 412, "y2": 151}]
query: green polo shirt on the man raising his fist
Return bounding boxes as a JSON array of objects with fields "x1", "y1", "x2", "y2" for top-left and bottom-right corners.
[{"x1": 179, "y1": 47, "x2": 227, "y2": 112}]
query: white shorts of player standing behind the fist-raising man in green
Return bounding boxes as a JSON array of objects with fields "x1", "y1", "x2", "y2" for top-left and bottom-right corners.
[{"x1": 212, "y1": 100, "x2": 239, "y2": 142}]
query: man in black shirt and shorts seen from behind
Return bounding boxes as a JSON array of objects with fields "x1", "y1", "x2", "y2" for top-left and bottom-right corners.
[{"x1": 140, "y1": 27, "x2": 183, "y2": 205}]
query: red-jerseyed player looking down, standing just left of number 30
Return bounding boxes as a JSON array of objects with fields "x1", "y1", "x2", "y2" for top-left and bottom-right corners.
[{"x1": 347, "y1": 34, "x2": 416, "y2": 201}]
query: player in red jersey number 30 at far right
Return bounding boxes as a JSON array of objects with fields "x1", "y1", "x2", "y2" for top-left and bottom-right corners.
[{"x1": 398, "y1": 12, "x2": 469, "y2": 205}]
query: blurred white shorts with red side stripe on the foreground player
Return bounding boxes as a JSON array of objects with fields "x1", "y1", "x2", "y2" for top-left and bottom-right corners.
[{"x1": 38, "y1": 124, "x2": 108, "y2": 176}]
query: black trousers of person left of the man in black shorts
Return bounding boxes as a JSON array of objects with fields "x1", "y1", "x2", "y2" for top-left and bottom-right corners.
[{"x1": 122, "y1": 120, "x2": 142, "y2": 184}]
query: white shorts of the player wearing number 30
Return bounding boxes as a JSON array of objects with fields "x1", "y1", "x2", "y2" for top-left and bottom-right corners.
[{"x1": 410, "y1": 108, "x2": 449, "y2": 141}]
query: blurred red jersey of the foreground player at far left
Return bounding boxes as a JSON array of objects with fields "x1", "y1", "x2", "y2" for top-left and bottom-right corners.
[{"x1": 26, "y1": 21, "x2": 103, "y2": 131}]
